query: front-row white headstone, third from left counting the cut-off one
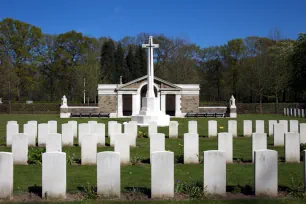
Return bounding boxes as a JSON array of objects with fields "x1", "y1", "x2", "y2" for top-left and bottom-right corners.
[{"x1": 97, "y1": 152, "x2": 120, "y2": 198}]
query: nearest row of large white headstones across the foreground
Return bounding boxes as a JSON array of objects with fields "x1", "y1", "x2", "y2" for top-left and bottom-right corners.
[{"x1": 0, "y1": 150, "x2": 306, "y2": 198}]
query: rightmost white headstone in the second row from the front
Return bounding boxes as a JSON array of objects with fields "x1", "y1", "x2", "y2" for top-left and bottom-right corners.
[{"x1": 285, "y1": 132, "x2": 300, "y2": 163}]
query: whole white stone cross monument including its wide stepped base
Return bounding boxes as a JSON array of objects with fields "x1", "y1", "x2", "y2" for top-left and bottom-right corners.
[{"x1": 132, "y1": 36, "x2": 170, "y2": 126}]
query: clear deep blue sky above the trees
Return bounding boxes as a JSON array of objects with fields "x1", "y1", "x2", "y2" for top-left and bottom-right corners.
[{"x1": 0, "y1": 0, "x2": 306, "y2": 47}]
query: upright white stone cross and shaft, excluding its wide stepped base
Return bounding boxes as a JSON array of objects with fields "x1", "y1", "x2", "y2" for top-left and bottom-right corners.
[{"x1": 142, "y1": 36, "x2": 159, "y2": 98}]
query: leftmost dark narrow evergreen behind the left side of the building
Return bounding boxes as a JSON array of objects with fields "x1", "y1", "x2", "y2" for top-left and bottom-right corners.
[{"x1": 100, "y1": 39, "x2": 119, "y2": 83}]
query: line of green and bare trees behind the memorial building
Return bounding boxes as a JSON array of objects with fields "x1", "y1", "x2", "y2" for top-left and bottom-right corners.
[{"x1": 0, "y1": 18, "x2": 306, "y2": 107}]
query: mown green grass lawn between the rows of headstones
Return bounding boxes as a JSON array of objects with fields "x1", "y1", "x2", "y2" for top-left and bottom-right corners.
[{"x1": 0, "y1": 115, "x2": 306, "y2": 203}]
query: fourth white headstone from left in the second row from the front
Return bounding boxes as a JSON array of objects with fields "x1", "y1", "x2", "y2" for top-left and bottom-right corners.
[{"x1": 113, "y1": 133, "x2": 130, "y2": 165}]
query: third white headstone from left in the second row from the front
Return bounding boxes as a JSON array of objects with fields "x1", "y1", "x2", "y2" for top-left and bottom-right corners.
[{"x1": 81, "y1": 133, "x2": 97, "y2": 165}]
